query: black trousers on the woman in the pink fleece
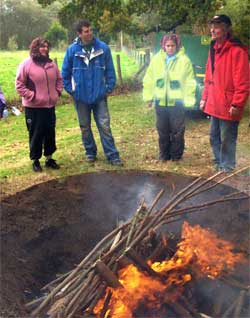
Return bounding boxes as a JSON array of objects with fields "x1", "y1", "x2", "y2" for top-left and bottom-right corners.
[{"x1": 25, "y1": 107, "x2": 56, "y2": 160}]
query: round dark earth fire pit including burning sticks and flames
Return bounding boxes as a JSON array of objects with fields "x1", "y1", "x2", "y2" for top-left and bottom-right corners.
[{"x1": 0, "y1": 172, "x2": 249, "y2": 318}]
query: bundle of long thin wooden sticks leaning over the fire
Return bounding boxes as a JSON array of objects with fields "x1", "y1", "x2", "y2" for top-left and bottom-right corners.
[{"x1": 26, "y1": 167, "x2": 249, "y2": 318}]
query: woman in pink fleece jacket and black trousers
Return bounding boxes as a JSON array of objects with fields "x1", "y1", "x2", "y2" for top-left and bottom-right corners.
[{"x1": 16, "y1": 37, "x2": 63, "y2": 172}]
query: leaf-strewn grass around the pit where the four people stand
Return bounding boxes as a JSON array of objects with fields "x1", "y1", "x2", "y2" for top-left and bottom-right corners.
[{"x1": 0, "y1": 92, "x2": 250, "y2": 196}]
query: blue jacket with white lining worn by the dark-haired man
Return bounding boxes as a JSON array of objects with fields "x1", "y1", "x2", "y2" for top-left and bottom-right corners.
[{"x1": 62, "y1": 38, "x2": 116, "y2": 104}]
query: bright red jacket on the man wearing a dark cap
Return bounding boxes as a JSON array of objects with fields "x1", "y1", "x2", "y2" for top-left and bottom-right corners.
[{"x1": 202, "y1": 39, "x2": 249, "y2": 121}]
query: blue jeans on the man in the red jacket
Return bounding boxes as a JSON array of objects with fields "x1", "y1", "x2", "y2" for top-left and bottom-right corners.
[{"x1": 210, "y1": 116, "x2": 239, "y2": 170}]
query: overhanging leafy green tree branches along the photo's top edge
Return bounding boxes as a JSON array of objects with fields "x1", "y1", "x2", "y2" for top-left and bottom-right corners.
[{"x1": 38, "y1": 0, "x2": 224, "y2": 34}]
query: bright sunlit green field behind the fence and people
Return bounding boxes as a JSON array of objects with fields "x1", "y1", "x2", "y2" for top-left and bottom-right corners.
[{"x1": 0, "y1": 50, "x2": 139, "y2": 103}]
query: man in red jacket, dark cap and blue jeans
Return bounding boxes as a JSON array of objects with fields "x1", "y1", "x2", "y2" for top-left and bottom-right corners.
[{"x1": 200, "y1": 14, "x2": 249, "y2": 172}]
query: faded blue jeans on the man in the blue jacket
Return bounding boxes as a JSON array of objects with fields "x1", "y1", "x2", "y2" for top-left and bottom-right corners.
[{"x1": 75, "y1": 99, "x2": 119, "y2": 161}]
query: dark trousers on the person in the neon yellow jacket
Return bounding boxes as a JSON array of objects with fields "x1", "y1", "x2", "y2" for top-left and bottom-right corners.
[{"x1": 155, "y1": 106, "x2": 185, "y2": 160}]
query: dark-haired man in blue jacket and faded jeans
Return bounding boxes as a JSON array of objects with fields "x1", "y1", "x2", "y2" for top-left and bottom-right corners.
[{"x1": 62, "y1": 19, "x2": 122, "y2": 166}]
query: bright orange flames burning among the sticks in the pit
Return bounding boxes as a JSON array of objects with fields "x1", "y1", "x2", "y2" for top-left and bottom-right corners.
[{"x1": 91, "y1": 223, "x2": 245, "y2": 318}]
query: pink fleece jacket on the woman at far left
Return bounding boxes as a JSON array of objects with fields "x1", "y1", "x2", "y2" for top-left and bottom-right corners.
[{"x1": 16, "y1": 57, "x2": 63, "y2": 108}]
